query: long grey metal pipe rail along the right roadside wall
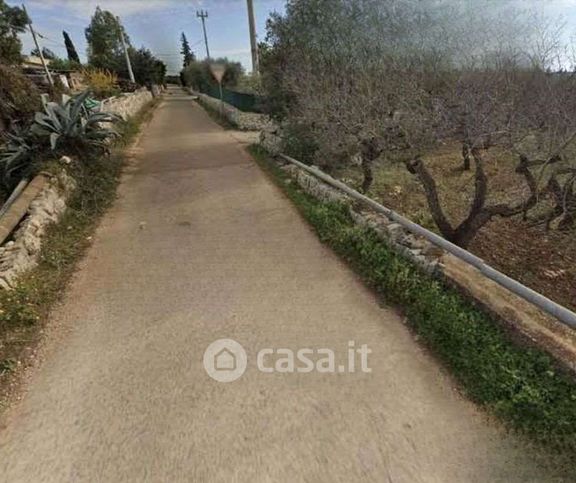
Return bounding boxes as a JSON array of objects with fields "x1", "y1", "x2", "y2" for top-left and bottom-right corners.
[{"x1": 280, "y1": 154, "x2": 576, "y2": 329}]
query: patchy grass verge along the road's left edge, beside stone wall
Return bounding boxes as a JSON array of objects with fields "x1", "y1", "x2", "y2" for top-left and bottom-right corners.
[{"x1": 0, "y1": 96, "x2": 159, "y2": 408}]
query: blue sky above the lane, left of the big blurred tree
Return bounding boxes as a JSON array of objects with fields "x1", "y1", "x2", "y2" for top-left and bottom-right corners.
[{"x1": 6, "y1": 0, "x2": 285, "y2": 73}]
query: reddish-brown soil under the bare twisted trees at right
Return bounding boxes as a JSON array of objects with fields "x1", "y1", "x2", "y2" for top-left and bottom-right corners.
[{"x1": 338, "y1": 145, "x2": 576, "y2": 310}]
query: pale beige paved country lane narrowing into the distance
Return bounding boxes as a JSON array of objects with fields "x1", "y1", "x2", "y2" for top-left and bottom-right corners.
[{"x1": 0, "y1": 90, "x2": 560, "y2": 483}]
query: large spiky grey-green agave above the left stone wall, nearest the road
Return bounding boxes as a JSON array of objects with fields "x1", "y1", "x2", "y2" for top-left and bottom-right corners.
[{"x1": 30, "y1": 91, "x2": 120, "y2": 154}]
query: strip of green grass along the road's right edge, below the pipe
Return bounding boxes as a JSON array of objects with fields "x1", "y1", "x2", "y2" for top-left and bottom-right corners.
[{"x1": 250, "y1": 146, "x2": 576, "y2": 465}]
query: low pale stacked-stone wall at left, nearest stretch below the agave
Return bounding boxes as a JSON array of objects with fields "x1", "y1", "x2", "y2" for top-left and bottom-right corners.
[{"x1": 0, "y1": 171, "x2": 76, "y2": 289}]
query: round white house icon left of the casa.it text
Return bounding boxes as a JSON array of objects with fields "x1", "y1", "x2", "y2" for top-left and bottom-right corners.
[{"x1": 204, "y1": 339, "x2": 248, "y2": 382}]
